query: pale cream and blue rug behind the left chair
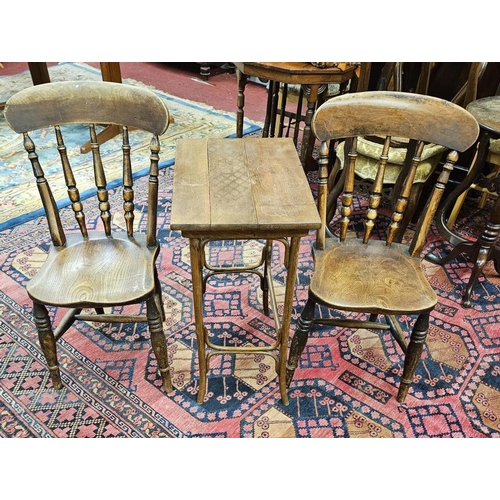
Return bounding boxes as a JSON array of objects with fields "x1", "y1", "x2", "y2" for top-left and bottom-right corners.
[{"x1": 0, "y1": 63, "x2": 261, "y2": 230}]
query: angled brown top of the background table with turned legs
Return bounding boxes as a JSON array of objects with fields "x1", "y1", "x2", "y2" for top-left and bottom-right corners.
[{"x1": 233, "y1": 62, "x2": 358, "y2": 85}]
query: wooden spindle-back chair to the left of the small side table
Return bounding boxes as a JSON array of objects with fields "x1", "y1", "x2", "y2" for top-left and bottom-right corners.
[{"x1": 5, "y1": 82, "x2": 172, "y2": 392}]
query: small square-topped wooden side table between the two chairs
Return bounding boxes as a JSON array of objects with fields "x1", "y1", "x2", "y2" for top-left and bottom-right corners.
[{"x1": 170, "y1": 138, "x2": 321, "y2": 404}]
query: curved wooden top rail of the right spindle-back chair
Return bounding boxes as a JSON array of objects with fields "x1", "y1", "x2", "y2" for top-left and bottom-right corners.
[{"x1": 312, "y1": 91, "x2": 479, "y2": 152}]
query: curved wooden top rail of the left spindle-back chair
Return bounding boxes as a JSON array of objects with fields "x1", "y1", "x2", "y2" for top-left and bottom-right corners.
[{"x1": 4, "y1": 81, "x2": 169, "y2": 135}]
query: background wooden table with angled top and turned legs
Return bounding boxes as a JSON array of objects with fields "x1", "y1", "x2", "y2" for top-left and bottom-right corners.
[{"x1": 234, "y1": 62, "x2": 357, "y2": 170}]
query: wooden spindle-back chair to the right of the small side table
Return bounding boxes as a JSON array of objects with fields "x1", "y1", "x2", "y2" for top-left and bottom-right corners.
[{"x1": 286, "y1": 91, "x2": 479, "y2": 402}]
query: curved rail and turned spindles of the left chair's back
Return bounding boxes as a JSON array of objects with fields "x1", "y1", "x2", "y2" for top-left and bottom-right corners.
[{"x1": 5, "y1": 81, "x2": 169, "y2": 250}]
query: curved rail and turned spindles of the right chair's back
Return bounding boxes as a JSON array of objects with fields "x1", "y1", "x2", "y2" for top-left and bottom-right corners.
[{"x1": 312, "y1": 91, "x2": 479, "y2": 255}]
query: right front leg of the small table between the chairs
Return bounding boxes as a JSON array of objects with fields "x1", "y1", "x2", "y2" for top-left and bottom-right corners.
[{"x1": 278, "y1": 236, "x2": 300, "y2": 406}]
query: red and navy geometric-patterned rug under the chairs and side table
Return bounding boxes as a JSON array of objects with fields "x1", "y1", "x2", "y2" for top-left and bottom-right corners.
[{"x1": 0, "y1": 160, "x2": 500, "y2": 438}]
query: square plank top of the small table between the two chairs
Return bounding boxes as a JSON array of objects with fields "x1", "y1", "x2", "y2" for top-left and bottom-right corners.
[{"x1": 170, "y1": 138, "x2": 321, "y2": 239}]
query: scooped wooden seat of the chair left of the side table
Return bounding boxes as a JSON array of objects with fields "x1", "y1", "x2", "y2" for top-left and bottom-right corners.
[{"x1": 27, "y1": 233, "x2": 158, "y2": 307}]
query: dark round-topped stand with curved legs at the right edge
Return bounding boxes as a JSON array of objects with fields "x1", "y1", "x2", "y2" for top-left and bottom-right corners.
[{"x1": 427, "y1": 96, "x2": 500, "y2": 307}]
